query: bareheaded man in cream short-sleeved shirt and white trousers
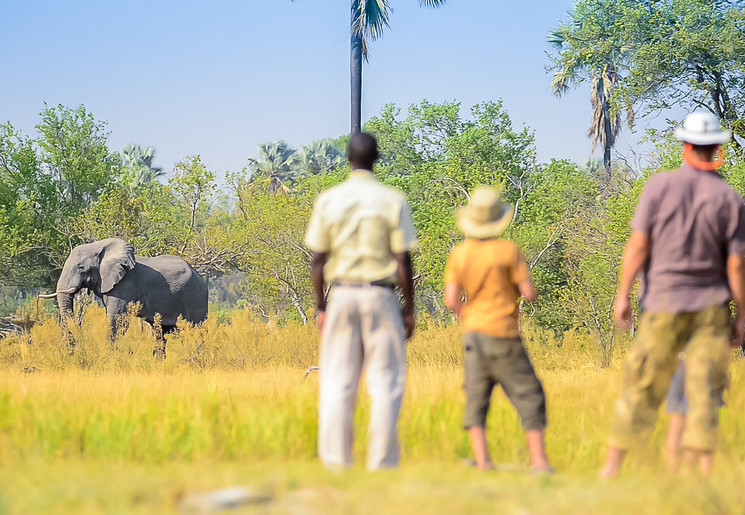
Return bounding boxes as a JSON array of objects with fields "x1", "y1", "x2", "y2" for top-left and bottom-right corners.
[{"x1": 305, "y1": 133, "x2": 416, "y2": 470}]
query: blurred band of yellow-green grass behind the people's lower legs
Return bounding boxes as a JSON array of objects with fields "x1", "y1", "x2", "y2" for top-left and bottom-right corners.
[{"x1": 0, "y1": 350, "x2": 745, "y2": 473}]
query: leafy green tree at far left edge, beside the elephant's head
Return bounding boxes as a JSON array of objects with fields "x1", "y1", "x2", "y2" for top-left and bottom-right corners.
[{"x1": 0, "y1": 106, "x2": 121, "y2": 286}]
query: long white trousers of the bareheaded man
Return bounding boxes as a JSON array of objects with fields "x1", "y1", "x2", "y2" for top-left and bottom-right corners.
[{"x1": 318, "y1": 286, "x2": 406, "y2": 470}]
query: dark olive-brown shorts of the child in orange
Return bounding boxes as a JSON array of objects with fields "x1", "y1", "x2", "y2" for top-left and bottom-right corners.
[{"x1": 463, "y1": 333, "x2": 546, "y2": 431}]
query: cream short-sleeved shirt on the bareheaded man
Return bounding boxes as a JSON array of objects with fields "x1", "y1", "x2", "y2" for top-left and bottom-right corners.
[{"x1": 305, "y1": 170, "x2": 416, "y2": 283}]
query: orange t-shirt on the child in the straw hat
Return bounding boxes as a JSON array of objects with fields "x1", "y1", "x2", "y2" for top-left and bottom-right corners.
[{"x1": 445, "y1": 239, "x2": 530, "y2": 338}]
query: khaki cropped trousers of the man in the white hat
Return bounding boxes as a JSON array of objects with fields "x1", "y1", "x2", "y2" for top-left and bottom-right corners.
[{"x1": 610, "y1": 306, "x2": 730, "y2": 452}]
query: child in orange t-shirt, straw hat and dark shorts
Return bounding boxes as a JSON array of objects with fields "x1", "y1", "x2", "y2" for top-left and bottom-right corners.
[{"x1": 445, "y1": 187, "x2": 553, "y2": 473}]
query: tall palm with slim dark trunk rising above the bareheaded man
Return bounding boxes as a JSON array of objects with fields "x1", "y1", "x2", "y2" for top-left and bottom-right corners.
[{"x1": 349, "y1": 0, "x2": 446, "y2": 134}]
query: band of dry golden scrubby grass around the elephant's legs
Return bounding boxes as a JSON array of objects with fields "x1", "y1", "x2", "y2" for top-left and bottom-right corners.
[{"x1": 0, "y1": 305, "x2": 625, "y2": 372}]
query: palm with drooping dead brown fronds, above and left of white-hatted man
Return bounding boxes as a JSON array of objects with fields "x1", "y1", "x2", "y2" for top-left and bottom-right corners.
[{"x1": 548, "y1": 31, "x2": 633, "y2": 176}]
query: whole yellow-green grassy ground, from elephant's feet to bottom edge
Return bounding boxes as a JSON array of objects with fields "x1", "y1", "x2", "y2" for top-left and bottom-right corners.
[{"x1": 0, "y1": 306, "x2": 745, "y2": 514}]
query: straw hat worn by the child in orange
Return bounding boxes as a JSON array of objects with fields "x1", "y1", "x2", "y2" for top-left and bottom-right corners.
[{"x1": 455, "y1": 186, "x2": 514, "y2": 240}]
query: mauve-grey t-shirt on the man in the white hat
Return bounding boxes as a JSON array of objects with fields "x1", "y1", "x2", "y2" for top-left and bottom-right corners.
[{"x1": 631, "y1": 165, "x2": 745, "y2": 313}]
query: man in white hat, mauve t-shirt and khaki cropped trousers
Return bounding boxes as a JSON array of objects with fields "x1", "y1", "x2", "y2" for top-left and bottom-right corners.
[{"x1": 601, "y1": 112, "x2": 745, "y2": 478}]
